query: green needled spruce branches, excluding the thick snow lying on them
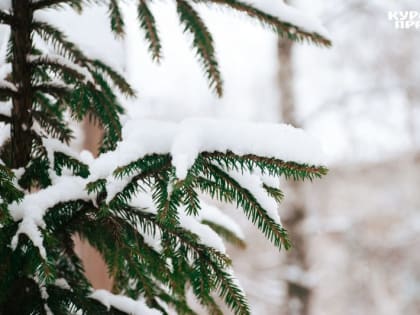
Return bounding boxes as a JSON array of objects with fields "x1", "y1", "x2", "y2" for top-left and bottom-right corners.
[{"x1": 0, "y1": 0, "x2": 330, "y2": 314}]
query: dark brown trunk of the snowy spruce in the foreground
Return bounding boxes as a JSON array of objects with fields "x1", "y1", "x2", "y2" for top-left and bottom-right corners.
[{"x1": 11, "y1": 0, "x2": 33, "y2": 168}]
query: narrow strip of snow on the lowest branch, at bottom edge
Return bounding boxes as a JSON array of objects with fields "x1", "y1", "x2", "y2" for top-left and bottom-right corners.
[{"x1": 90, "y1": 290, "x2": 160, "y2": 315}]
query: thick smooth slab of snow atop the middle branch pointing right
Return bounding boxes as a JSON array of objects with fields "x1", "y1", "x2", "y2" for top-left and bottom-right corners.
[{"x1": 116, "y1": 118, "x2": 324, "y2": 179}]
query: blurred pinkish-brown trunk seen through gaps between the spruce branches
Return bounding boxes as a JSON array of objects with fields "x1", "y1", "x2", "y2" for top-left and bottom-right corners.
[{"x1": 75, "y1": 119, "x2": 112, "y2": 290}]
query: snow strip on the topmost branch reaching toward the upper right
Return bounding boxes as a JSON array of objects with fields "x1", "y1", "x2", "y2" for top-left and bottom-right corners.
[{"x1": 246, "y1": 0, "x2": 330, "y2": 38}]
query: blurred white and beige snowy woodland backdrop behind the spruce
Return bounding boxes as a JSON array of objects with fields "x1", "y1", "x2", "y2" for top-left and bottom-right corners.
[{"x1": 0, "y1": 0, "x2": 420, "y2": 315}]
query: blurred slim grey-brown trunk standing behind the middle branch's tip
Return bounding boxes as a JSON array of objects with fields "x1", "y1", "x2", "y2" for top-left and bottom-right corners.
[{"x1": 278, "y1": 25, "x2": 311, "y2": 315}]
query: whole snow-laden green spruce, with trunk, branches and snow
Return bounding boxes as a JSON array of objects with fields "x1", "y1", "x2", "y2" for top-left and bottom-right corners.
[{"x1": 0, "y1": 0, "x2": 330, "y2": 314}]
